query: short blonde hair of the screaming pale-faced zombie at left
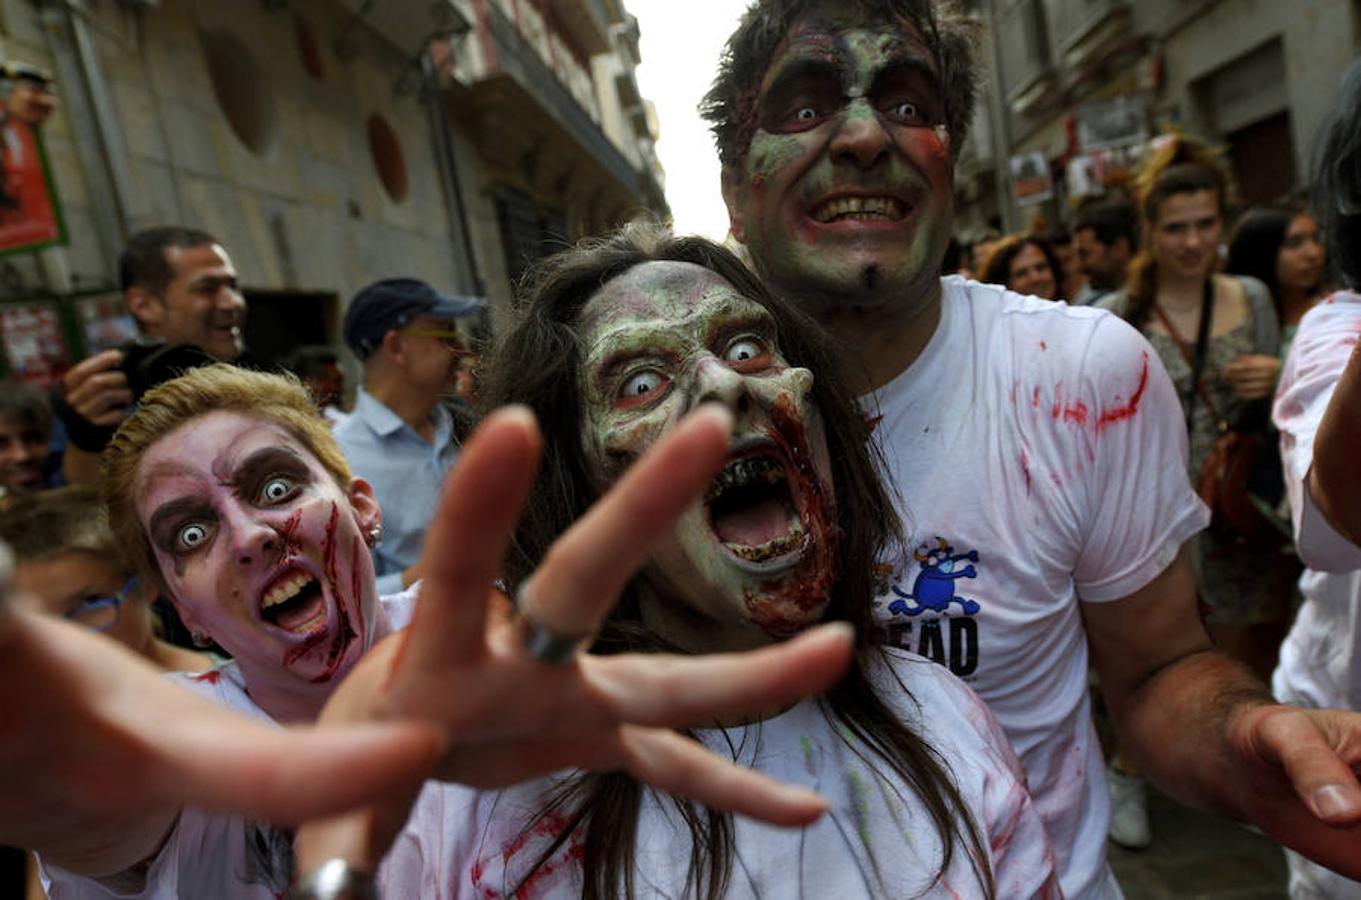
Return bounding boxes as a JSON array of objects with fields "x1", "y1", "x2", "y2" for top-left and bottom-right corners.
[{"x1": 102, "y1": 362, "x2": 354, "y2": 588}]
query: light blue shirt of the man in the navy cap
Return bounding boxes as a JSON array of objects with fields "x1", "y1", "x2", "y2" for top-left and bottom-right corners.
[{"x1": 335, "y1": 388, "x2": 459, "y2": 595}]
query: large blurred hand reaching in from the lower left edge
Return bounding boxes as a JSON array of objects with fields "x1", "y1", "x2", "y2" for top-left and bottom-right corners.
[{"x1": 0, "y1": 603, "x2": 441, "y2": 874}]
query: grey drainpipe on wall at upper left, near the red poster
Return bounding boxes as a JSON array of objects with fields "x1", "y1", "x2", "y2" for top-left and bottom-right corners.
[{"x1": 42, "y1": 0, "x2": 132, "y2": 254}]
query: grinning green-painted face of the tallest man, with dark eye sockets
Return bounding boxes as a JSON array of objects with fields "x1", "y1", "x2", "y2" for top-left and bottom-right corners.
[{"x1": 725, "y1": 18, "x2": 954, "y2": 320}]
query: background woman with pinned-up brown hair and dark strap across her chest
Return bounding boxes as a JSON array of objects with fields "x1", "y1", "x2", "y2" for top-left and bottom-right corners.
[{"x1": 1097, "y1": 138, "x2": 1298, "y2": 847}]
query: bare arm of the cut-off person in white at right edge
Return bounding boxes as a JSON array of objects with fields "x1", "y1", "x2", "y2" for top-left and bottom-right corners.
[{"x1": 1308, "y1": 344, "x2": 1361, "y2": 545}]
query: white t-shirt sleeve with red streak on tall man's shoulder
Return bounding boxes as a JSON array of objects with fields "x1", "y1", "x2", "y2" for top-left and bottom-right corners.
[{"x1": 1074, "y1": 316, "x2": 1210, "y2": 602}]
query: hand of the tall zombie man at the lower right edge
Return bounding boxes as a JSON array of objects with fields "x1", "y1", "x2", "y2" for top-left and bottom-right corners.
[{"x1": 1232, "y1": 704, "x2": 1361, "y2": 878}]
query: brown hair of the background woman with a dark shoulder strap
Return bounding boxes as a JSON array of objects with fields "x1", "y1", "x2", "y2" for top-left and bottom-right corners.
[{"x1": 1124, "y1": 138, "x2": 1230, "y2": 328}]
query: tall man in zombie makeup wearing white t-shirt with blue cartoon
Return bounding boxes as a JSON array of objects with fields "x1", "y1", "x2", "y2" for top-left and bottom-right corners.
[{"x1": 702, "y1": 0, "x2": 1361, "y2": 897}]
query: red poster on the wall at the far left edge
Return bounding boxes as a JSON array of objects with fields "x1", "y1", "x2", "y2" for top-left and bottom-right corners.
[{"x1": 0, "y1": 117, "x2": 65, "y2": 253}]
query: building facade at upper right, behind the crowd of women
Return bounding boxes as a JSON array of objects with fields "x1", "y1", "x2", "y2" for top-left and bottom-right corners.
[{"x1": 958, "y1": 0, "x2": 1361, "y2": 234}]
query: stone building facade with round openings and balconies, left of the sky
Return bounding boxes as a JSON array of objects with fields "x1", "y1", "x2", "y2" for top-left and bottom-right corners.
[{"x1": 0, "y1": 0, "x2": 666, "y2": 381}]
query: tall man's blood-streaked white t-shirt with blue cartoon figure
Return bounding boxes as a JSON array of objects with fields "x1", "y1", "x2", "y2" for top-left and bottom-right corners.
[{"x1": 864, "y1": 276, "x2": 1209, "y2": 897}]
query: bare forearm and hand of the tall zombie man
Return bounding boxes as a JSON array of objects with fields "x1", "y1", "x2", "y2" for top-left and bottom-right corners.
[{"x1": 1082, "y1": 547, "x2": 1361, "y2": 878}]
